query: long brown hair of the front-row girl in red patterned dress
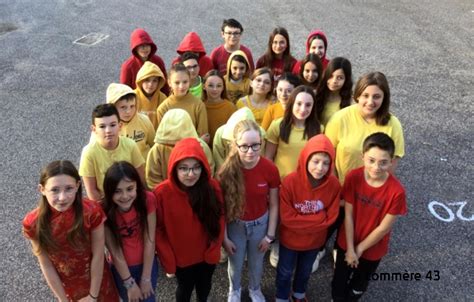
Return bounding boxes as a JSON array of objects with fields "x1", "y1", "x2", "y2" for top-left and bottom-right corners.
[{"x1": 33, "y1": 160, "x2": 86, "y2": 255}]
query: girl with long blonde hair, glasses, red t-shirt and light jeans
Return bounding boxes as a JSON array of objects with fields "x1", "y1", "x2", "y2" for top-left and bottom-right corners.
[{"x1": 218, "y1": 120, "x2": 280, "y2": 302}]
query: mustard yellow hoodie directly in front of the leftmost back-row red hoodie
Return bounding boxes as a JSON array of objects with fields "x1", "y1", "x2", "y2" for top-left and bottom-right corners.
[{"x1": 135, "y1": 61, "x2": 167, "y2": 130}]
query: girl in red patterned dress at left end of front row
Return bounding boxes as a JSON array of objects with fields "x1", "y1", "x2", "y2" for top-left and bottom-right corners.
[{"x1": 23, "y1": 161, "x2": 119, "y2": 302}]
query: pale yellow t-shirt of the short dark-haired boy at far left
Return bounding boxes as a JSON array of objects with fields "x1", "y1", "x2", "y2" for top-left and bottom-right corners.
[{"x1": 79, "y1": 136, "x2": 145, "y2": 195}]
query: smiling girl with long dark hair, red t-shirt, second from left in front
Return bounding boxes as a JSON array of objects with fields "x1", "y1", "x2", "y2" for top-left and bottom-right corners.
[{"x1": 103, "y1": 161, "x2": 158, "y2": 302}]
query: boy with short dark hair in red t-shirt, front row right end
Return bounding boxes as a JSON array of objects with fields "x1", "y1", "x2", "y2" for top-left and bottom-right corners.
[{"x1": 332, "y1": 132, "x2": 407, "y2": 301}]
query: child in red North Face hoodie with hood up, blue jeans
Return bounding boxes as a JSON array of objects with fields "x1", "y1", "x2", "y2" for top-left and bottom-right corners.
[{"x1": 276, "y1": 134, "x2": 341, "y2": 302}]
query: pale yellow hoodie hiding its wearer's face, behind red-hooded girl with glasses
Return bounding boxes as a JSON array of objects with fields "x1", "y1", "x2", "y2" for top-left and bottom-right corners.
[{"x1": 145, "y1": 108, "x2": 215, "y2": 189}]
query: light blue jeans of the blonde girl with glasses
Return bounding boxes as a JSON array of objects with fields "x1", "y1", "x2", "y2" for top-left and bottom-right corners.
[{"x1": 227, "y1": 212, "x2": 268, "y2": 290}]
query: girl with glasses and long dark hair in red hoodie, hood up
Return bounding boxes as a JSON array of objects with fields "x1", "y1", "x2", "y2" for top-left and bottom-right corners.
[{"x1": 153, "y1": 138, "x2": 225, "y2": 302}]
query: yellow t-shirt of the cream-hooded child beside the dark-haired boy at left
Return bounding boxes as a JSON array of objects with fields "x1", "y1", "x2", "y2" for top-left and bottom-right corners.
[{"x1": 120, "y1": 113, "x2": 155, "y2": 159}]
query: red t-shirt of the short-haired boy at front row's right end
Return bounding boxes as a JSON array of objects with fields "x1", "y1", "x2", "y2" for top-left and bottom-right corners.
[{"x1": 337, "y1": 167, "x2": 407, "y2": 260}]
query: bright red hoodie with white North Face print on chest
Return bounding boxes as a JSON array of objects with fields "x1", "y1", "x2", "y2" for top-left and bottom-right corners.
[{"x1": 280, "y1": 134, "x2": 341, "y2": 251}]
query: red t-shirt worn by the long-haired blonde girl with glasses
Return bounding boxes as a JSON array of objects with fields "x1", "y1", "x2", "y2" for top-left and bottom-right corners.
[{"x1": 240, "y1": 157, "x2": 280, "y2": 221}]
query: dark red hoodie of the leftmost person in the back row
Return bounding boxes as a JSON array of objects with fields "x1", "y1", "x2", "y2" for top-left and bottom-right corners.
[{"x1": 120, "y1": 28, "x2": 169, "y2": 95}]
